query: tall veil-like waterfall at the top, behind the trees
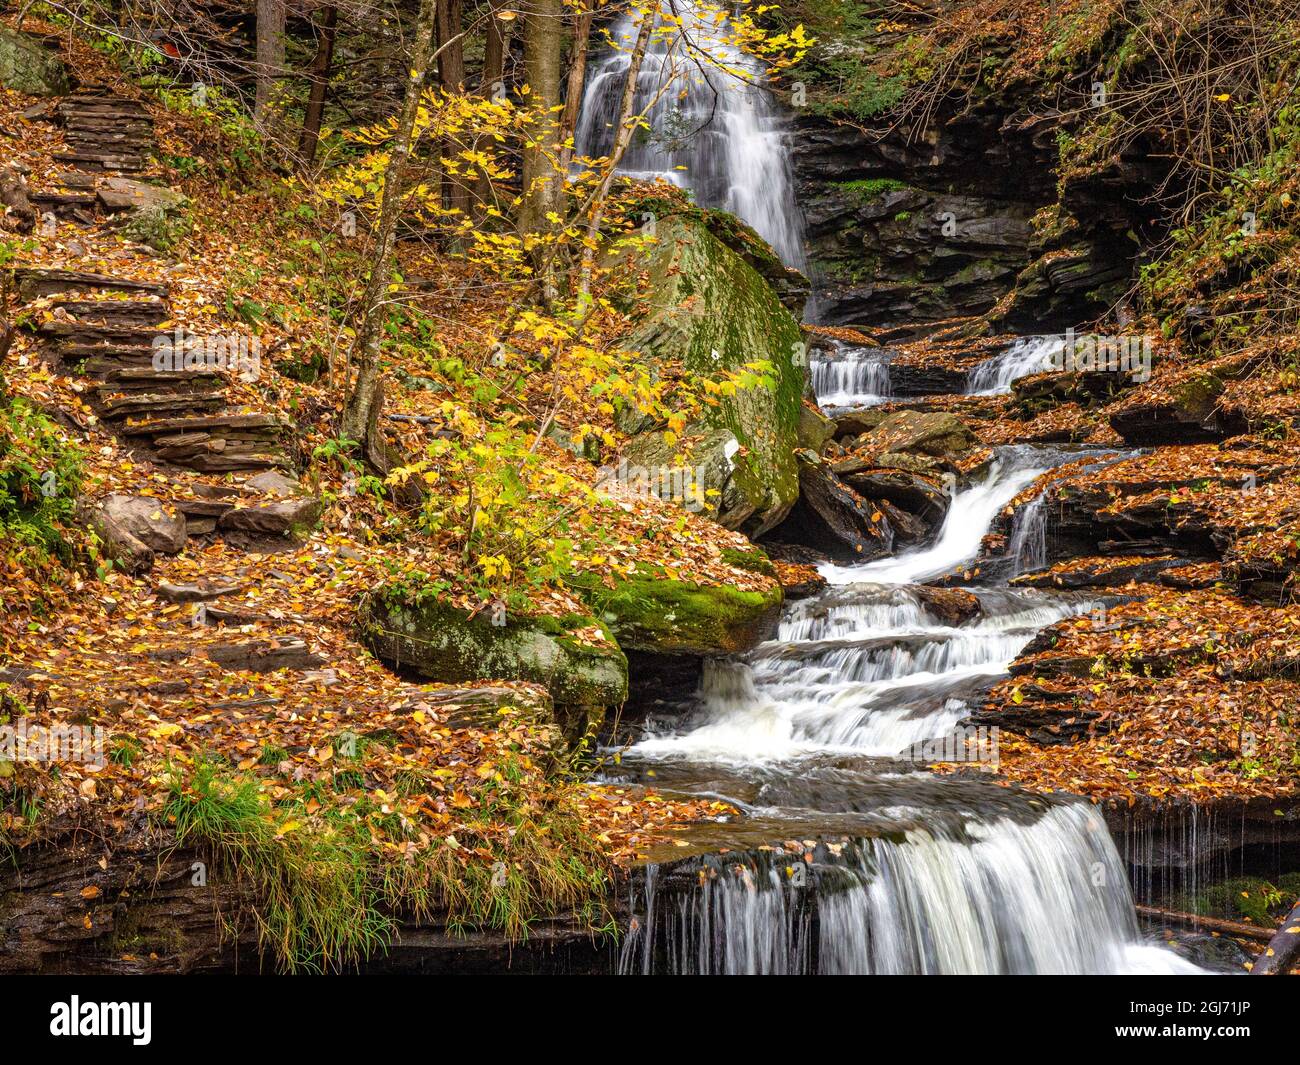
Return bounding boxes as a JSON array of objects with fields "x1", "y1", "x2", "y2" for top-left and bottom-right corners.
[{"x1": 575, "y1": 0, "x2": 803, "y2": 268}]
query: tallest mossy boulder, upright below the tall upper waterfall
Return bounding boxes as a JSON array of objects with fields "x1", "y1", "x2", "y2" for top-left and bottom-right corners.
[{"x1": 621, "y1": 215, "x2": 806, "y2": 536}]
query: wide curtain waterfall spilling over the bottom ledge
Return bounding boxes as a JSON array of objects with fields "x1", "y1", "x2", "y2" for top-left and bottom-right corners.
[{"x1": 619, "y1": 802, "x2": 1196, "y2": 974}]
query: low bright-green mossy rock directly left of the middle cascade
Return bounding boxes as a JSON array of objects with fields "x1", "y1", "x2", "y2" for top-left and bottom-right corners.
[{"x1": 577, "y1": 569, "x2": 783, "y2": 655}]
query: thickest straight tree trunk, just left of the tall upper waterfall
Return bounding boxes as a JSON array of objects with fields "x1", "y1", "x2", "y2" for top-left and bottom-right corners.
[{"x1": 519, "y1": 0, "x2": 564, "y2": 303}]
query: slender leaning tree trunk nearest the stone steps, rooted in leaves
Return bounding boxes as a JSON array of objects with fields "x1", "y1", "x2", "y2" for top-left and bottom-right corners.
[{"x1": 339, "y1": 0, "x2": 437, "y2": 452}]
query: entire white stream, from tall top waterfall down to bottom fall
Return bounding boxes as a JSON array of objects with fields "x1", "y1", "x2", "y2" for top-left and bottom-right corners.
[{"x1": 576, "y1": 0, "x2": 1200, "y2": 974}]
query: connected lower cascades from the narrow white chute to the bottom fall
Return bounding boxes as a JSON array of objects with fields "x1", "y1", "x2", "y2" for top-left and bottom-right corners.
[{"x1": 620, "y1": 447, "x2": 1196, "y2": 973}]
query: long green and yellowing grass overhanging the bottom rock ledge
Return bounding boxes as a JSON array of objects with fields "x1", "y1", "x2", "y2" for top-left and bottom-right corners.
[{"x1": 163, "y1": 757, "x2": 615, "y2": 971}]
